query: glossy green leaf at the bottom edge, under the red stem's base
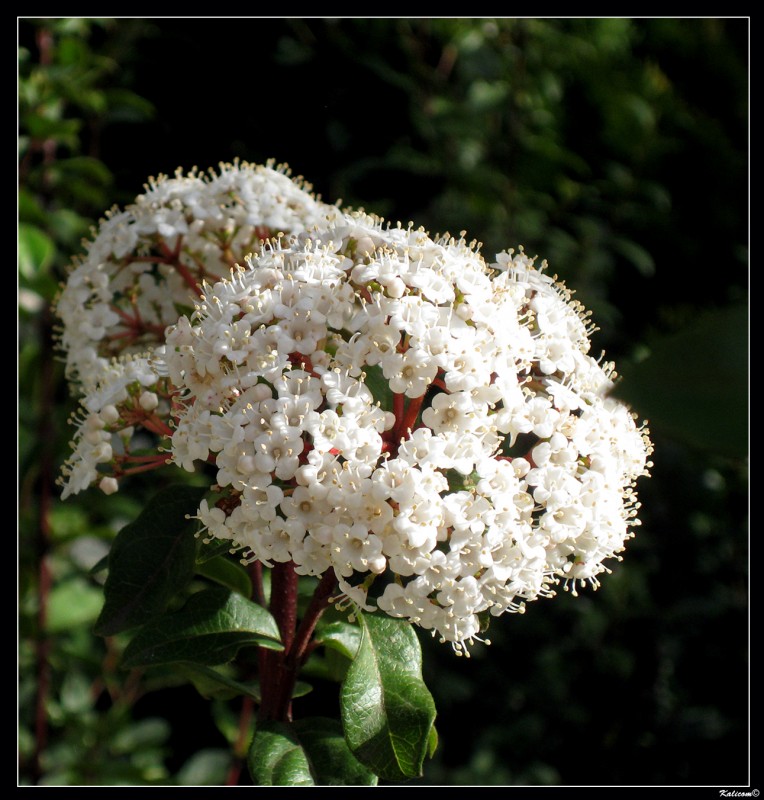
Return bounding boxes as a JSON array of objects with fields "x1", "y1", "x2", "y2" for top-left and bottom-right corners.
[{"x1": 248, "y1": 717, "x2": 377, "y2": 786}]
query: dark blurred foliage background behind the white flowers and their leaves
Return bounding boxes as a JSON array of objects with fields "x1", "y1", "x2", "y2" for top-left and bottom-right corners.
[{"x1": 19, "y1": 18, "x2": 755, "y2": 786}]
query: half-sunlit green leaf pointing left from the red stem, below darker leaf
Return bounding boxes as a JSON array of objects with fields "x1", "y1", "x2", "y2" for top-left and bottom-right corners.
[{"x1": 123, "y1": 587, "x2": 283, "y2": 667}]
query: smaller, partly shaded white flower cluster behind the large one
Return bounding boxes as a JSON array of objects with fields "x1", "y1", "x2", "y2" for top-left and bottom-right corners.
[{"x1": 56, "y1": 162, "x2": 333, "y2": 497}]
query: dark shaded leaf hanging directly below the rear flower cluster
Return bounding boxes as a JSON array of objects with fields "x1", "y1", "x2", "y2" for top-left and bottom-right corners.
[{"x1": 95, "y1": 486, "x2": 205, "y2": 636}]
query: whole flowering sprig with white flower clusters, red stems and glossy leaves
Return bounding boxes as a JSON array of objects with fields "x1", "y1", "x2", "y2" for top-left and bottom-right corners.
[{"x1": 58, "y1": 159, "x2": 651, "y2": 783}]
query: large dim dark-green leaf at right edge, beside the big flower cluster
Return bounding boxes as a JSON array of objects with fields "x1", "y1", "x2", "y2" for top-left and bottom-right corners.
[{"x1": 613, "y1": 307, "x2": 748, "y2": 458}]
